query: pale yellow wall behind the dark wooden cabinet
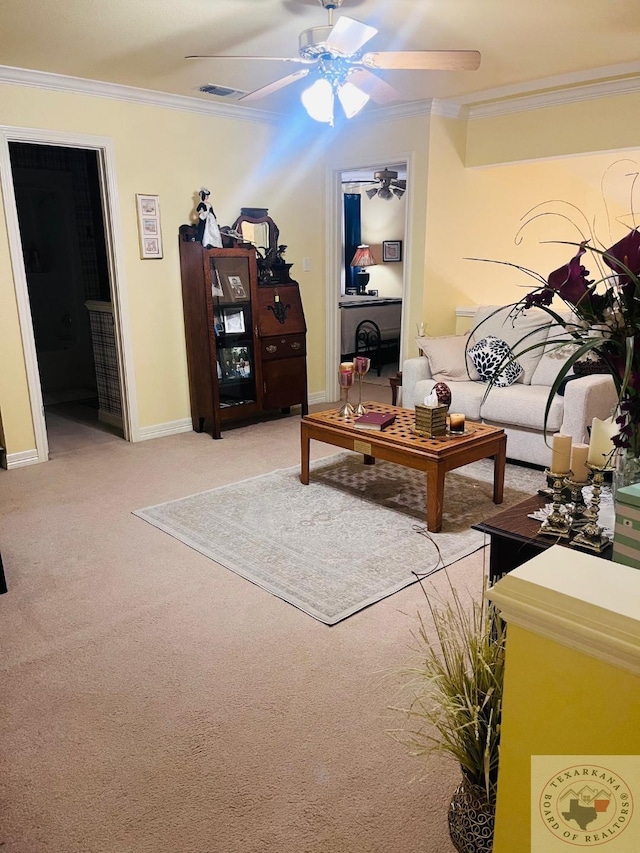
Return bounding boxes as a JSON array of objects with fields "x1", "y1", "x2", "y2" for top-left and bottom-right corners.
[{"x1": 0, "y1": 85, "x2": 324, "y2": 454}]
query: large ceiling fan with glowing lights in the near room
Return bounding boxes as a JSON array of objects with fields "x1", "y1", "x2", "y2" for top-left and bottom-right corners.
[{"x1": 186, "y1": 0, "x2": 480, "y2": 124}]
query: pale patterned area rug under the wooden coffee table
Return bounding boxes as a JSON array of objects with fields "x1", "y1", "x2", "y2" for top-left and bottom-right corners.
[{"x1": 134, "y1": 453, "x2": 543, "y2": 625}]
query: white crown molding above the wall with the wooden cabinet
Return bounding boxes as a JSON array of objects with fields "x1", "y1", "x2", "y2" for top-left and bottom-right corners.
[{"x1": 0, "y1": 65, "x2": 282, "y2": 124}]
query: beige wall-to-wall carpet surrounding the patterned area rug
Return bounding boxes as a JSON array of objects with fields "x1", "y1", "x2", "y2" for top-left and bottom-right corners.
[{"x1": 0, "y1": 394, "x2": 528, "y2": 853}]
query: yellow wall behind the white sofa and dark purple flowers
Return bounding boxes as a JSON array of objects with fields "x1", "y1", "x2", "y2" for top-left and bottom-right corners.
[{"x1": 423, "y1": 108, "x2": 640, "y2": 352}]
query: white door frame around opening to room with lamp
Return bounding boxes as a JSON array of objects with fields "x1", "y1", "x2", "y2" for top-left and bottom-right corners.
[{"x1": 325, "y1": 151, "x2": 414, "y2": 400}]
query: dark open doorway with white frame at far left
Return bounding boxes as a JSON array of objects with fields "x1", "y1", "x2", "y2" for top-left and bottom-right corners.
[{"x1": 0, "y1": 135, "x2": 138, "y2": 467}]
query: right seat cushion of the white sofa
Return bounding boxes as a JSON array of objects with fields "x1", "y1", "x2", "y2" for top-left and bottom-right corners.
[{"x1": 480, "y1": 383, "x2": 564, "y2": 430}]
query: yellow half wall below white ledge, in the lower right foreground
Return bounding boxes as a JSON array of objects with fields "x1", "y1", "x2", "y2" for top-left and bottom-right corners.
[{"x1": 494, "y1": 624, "x2": 640, "y2": 853}]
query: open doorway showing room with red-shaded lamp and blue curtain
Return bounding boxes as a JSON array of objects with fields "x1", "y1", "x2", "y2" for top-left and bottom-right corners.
[{"x1": 338, "y1": 162, "x2": 407, "y2": 388}]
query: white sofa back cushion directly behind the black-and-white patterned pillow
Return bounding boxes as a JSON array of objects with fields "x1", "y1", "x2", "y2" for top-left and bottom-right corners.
[{"x1": 471, "y1": 305, "x2": 551, "y2": 385}]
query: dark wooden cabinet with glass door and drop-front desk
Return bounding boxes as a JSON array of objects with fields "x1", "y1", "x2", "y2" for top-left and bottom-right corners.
[{"x1": 180, "y1": 226, "x2": 308, "y2": 438}]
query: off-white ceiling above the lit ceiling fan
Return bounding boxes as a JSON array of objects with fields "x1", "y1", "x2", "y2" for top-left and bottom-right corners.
[{"x1": 0, "y1": 0, "x2": 640, "y2": 112}]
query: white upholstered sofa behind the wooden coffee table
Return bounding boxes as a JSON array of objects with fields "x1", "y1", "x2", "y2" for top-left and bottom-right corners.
[{"x1": 401, "y1": 305, "x2": 617, "y2": 466}]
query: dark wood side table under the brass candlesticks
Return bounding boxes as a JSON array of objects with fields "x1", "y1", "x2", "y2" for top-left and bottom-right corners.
[{"x1": 472, "y1": 495, "x2": 613, "y2": 585}]
